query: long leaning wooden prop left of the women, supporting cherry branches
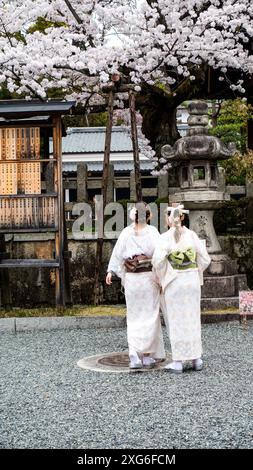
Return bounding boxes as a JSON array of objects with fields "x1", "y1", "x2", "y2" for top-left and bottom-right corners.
[{"x1": 94, "y1": 90, "x2": 114, "y2": 305}]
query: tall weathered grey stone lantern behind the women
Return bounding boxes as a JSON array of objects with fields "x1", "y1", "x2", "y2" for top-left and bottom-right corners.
[{"x1": 161, "y1": 101, "x2": 247, "y2": 308}]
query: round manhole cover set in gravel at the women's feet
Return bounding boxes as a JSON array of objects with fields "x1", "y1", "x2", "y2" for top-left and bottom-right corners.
[{"x1": 77, "y1": 351, "x2": 171, "y2": 372}]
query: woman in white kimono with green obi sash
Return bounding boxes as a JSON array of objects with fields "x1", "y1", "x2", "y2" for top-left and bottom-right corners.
[{"x1": 152, "y1": 205, "x2": 211, "y2": 373}]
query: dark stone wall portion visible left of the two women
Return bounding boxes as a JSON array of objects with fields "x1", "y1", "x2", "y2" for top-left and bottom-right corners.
[{"x1": 0, "y1": 234, "x2": 124, "y2": 307}]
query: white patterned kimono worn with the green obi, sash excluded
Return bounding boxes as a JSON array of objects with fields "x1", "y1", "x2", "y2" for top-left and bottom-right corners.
[{"x1": 153, "y1": 227, "x2": 211, "y2": 361}]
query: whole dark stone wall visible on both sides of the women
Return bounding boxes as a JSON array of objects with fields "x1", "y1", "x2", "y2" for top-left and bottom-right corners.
[{"x1": 0, "y1": 234, "x2": 253, "y2": 307}]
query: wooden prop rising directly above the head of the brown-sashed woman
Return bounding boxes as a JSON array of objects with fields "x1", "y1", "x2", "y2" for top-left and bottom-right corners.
[{"x1": 129, "y1": 90, "x2": 142, "y2": 201}]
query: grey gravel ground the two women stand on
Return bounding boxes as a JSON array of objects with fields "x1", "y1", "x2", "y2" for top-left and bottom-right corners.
[{"x1": 0, "y1": 322, "x2": 253, "y2": 449}]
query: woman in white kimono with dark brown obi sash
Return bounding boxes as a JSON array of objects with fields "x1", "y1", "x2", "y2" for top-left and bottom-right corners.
[{"x1": 106, "y1": 206, "x2": 165, "y2": 369}]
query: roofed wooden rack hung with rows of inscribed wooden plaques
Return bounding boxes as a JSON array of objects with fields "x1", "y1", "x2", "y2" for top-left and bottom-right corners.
[{"x1": 0, "y1": 100, "x2": 75, "y2": 306}]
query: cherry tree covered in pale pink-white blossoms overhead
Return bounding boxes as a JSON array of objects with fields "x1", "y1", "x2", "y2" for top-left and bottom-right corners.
[{"x1": 0, "y1": 0, "x2": 253, "y2": 172}]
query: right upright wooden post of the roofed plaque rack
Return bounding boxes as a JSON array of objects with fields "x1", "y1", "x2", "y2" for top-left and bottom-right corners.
[{"x1": 53, "y1": 116, "x2": 65, "y2": 307}]
